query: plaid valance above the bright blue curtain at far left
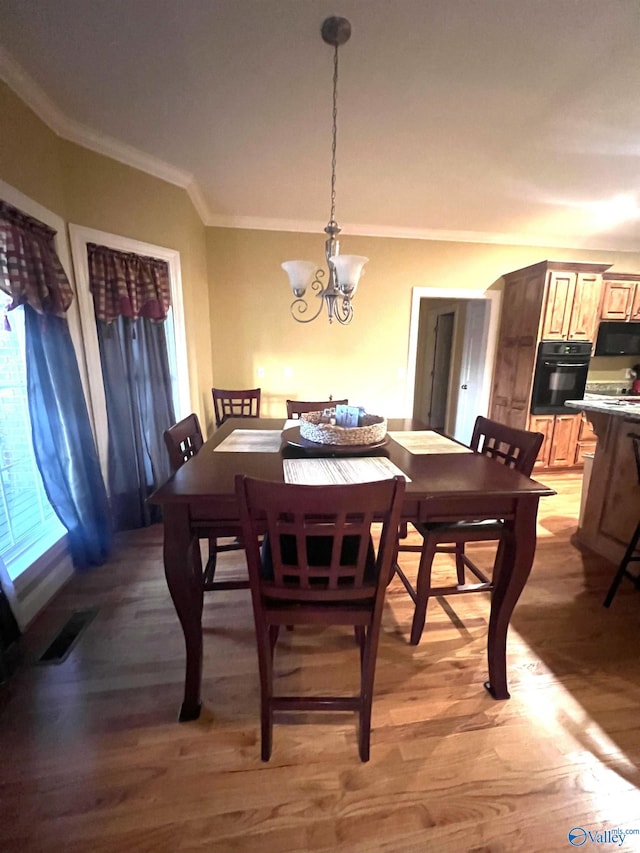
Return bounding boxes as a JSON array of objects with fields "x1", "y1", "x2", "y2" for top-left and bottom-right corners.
[{"x1": 0, "y1": 201, "x2": 73, "y2": 317}]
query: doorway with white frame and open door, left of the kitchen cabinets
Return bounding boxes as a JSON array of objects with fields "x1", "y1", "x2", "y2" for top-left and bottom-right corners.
[{"x1": 406, "y1": 287, "x2": 502, "y2": 444}]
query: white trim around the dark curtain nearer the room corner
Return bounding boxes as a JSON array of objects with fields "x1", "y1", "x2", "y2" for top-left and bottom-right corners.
[{"x1": 69, "y1": 224, "x2": 192, "y2": 483}]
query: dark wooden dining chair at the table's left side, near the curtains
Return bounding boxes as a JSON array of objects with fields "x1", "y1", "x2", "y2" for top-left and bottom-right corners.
[{"x1": 164, "y1": 412, "x2": 249, "y2": 590}]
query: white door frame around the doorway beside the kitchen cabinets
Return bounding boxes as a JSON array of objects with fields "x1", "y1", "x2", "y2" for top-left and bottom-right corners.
[{"x1": 405, "y1": 287, "x2": 502, "y2": 417}]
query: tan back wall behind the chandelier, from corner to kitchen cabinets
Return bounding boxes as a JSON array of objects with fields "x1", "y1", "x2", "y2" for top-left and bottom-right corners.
[{"x1": 207, "y1": 228, "x2": 640, "y2": 416}]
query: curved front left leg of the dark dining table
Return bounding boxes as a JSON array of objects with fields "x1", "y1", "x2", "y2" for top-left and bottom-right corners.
[{"x1": 164, "y1": 504, "x2": 203, "y2": 723}]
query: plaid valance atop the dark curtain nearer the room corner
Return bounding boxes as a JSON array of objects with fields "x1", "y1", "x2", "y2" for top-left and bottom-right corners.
[{"x1": 87, "y1": 243, "x2": 171, "y2": 323}]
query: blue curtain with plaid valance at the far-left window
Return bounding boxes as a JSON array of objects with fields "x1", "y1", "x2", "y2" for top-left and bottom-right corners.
[{"x1": 0, "y1": 201, "x2": 111, "y2": 569}]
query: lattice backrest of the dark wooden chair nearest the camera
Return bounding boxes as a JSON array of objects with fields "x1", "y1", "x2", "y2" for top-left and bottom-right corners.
[{"x1": 236, "y1": 475, "x2": 405, "y2": 603}]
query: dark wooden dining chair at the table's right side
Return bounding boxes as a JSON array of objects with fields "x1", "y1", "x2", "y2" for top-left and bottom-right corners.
[{"x1": 395, "y1": 416, "x2": 544, "y2": 645}]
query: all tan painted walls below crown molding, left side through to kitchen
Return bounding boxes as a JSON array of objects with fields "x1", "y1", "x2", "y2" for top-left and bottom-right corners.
[{"x1": 0, "y1": 78, "x2": 640, "y2": 427}]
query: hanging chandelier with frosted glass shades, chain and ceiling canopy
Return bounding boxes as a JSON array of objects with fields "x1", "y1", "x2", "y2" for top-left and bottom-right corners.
[{"x1": 282, "y1": 17, "x2": 369, "y2": 325}]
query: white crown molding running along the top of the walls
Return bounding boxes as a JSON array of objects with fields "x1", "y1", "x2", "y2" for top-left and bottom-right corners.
[{"x1": 0, "y1": 45, "x2": 638, "y2": 252}]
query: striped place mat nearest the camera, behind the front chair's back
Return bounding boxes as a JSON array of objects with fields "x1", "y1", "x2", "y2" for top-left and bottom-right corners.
[{"x1": 282, "y1": 456, "x2": 411, "y2": 486}]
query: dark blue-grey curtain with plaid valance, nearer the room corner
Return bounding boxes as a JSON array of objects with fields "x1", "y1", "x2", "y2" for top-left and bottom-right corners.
[{"x1": 87, "y1": 243, "x2": 175, "y2": 530}]
